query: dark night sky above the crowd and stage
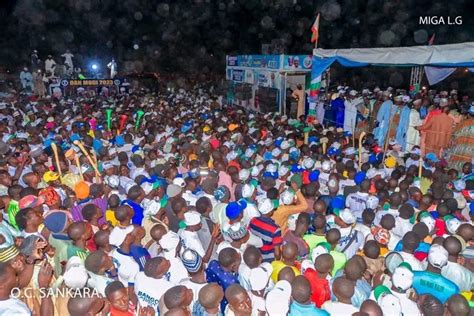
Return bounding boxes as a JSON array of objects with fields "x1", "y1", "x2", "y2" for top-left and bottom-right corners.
[{"x1": 0, "y1": 0, "x2": 474, "y2": 73}]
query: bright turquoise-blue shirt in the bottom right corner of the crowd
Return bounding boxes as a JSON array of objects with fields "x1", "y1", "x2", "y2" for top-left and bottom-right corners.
[{"x1": 413, "y1": 271, "x2": 459, "y2": 304}]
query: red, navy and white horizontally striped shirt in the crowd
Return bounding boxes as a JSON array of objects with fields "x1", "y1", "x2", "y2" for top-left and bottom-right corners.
[{"x1": 249, "y1": 216, "x2": 283, "y2": 263}]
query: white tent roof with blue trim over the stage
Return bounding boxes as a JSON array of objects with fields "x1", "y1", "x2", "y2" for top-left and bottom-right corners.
[{"x1": 313, "y1": 42, "x2": 474, "y2": 67}]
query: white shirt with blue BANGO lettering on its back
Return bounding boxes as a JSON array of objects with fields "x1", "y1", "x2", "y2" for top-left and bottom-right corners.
[{"x1": 135, "y1": 272, "x2": 173, "y2": 312}]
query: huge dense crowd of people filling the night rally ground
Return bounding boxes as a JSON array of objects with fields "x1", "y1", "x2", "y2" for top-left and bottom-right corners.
[{"x1": 0, "y1": 82, "x2": 474, "y2": 316}]
